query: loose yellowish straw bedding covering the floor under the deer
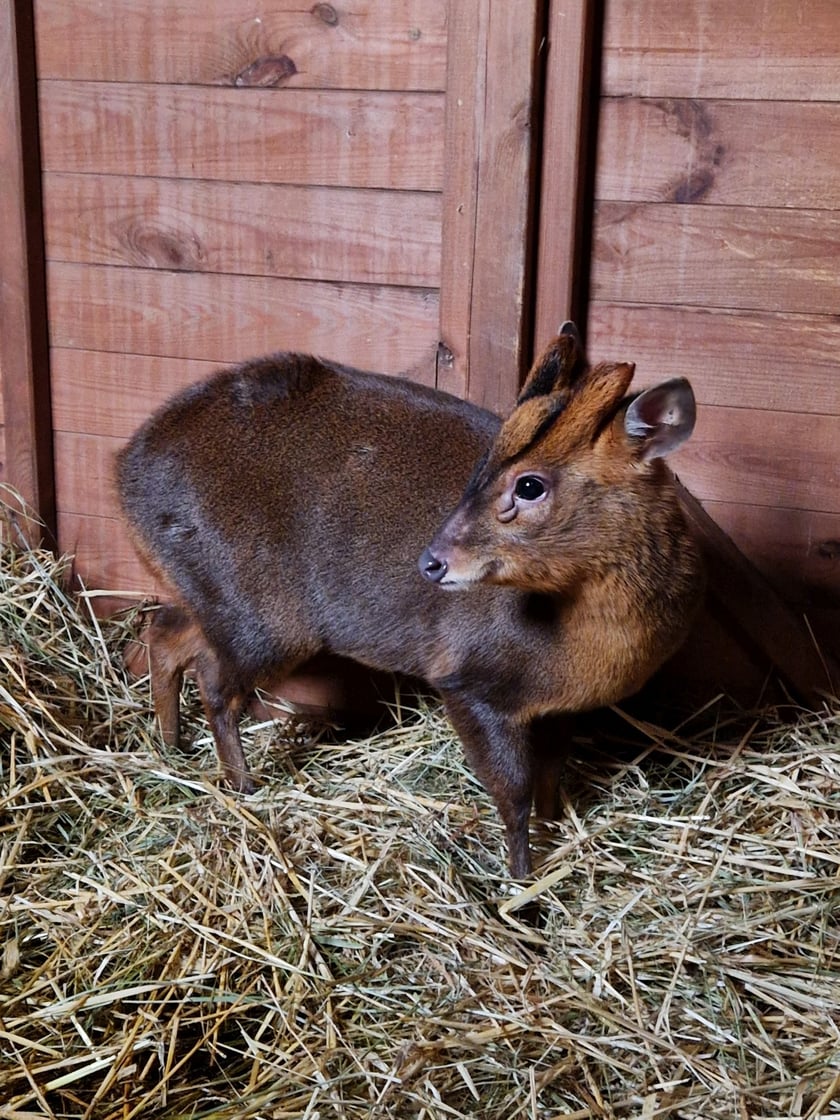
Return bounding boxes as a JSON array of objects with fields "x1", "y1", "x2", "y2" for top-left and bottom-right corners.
[{"x1": 0, "y1": 499, "x2": 840, "y2": 1120}]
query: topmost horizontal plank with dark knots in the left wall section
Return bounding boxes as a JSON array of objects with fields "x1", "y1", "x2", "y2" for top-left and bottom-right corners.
[{"x1": 35, "y1": 0, "x2": 448, "y2": 91}]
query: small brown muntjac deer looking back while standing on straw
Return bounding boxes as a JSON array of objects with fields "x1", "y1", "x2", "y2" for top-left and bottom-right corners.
[{"x1": 118, "y1": 324, "x2": 702, "y2": 877}]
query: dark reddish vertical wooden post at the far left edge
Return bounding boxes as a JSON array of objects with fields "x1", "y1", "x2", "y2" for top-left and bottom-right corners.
[{"x1": 0, "y1": 0, "x2": 56, "y2": 540}]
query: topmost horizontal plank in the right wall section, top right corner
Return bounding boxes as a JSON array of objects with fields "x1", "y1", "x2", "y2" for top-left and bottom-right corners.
[{"x1": 603, "y1": 0, "x2": 840, "y2": 101}]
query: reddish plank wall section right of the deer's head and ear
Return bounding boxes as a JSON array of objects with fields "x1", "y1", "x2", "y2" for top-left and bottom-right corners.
[{"x1": 589, "y1": 0, "x2": 840, "y2": 645}]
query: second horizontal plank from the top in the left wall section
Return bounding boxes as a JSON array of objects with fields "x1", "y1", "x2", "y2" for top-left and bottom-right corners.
[{"x1": 40, "y1": 81, "x2": 444, "y2": 190}]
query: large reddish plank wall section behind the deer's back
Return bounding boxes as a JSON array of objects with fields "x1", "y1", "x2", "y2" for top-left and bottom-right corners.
[{"x1": 22, "y1": 0, "x2": 542, "y2": 591}]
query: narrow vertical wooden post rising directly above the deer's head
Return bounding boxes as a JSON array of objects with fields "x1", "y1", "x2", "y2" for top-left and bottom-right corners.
[{"x1": 534, "y1": 0, "x2": 595, "y2": 353}]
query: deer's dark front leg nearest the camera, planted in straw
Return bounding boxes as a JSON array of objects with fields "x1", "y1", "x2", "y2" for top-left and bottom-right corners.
[{"x1": 444, "y1": 692, "x2": 533, "y2": 879}]
